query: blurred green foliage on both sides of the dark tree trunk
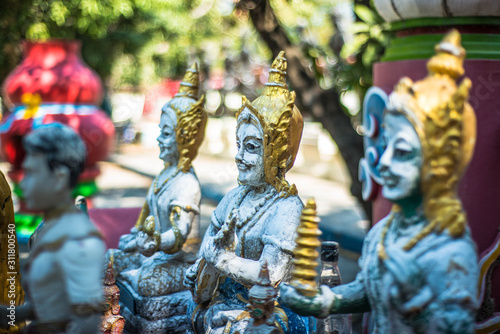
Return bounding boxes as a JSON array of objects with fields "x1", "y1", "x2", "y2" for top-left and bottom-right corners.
[{"x1": 0, "y1": 0, "x2": 388, "y2": 94}]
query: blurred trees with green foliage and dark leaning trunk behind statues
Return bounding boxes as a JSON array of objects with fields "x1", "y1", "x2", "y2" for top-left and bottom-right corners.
[{"x1": 0, "y1": 0, "x2": 390, "y2": 217}]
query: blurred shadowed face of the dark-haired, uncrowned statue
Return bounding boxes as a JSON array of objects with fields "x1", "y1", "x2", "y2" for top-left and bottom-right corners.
[{"x1": 20, "y1": 153, "x2": 60, "y2": 211}]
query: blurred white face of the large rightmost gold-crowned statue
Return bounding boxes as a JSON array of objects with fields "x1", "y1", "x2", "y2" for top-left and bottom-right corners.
[{"x1": 379, "y1": 114, "x2": 422, "y2": 204}]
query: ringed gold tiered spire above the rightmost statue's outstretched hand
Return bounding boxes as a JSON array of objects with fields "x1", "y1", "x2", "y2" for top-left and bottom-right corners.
[{"x1": 290, "y1": 198, "x2": 321, "y2": 297}]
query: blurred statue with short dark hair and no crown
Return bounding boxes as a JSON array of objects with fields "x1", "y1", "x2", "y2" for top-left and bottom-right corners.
[{"x1": 1, "y1": 123, "x2": 105, "y2": 334}]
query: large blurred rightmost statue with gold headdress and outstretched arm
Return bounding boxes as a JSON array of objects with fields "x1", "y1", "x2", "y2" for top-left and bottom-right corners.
[{"x1": 281, "y1": 31, "x2": 478, "y2": 334}]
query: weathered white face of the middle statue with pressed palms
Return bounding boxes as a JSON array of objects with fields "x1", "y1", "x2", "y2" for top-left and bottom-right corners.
[{"x1": 235, "y1": 113, "x2": 266, "y2": 187}]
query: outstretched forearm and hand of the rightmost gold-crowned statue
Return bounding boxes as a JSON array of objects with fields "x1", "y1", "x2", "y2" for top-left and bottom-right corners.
[{"x1": 280, "y1": 283, "x2": 338, "y2": 318}]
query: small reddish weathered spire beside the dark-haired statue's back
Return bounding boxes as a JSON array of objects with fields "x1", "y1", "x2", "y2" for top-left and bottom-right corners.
[{"x1": 100, "y1": 261, "x2": 125, "y2": 334}]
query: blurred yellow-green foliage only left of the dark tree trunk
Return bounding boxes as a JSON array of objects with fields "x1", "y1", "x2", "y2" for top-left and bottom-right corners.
[{"x1": 0, "y1": 0, "x2": 266, "y2": 88}]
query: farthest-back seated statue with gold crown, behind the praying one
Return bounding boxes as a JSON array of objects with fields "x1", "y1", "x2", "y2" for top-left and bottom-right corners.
[{"x1": 108, "y1": 64, "x2": 207, "y2": 333}]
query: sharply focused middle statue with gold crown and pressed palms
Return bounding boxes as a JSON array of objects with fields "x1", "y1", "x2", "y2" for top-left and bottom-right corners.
[{"x1": 185, "y1": 52, "x2": 306, "y2": 333}]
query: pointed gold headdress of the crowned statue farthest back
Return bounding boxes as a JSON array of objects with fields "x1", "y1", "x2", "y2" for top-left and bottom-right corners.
[{"x1": 163, "y1": 63, "x2": 207, "y2": 173}]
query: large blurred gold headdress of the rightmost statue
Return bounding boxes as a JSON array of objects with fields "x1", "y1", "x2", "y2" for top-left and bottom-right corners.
[{"x1": 387, "y1": 30, "x2": 476, "y2": 250}]
